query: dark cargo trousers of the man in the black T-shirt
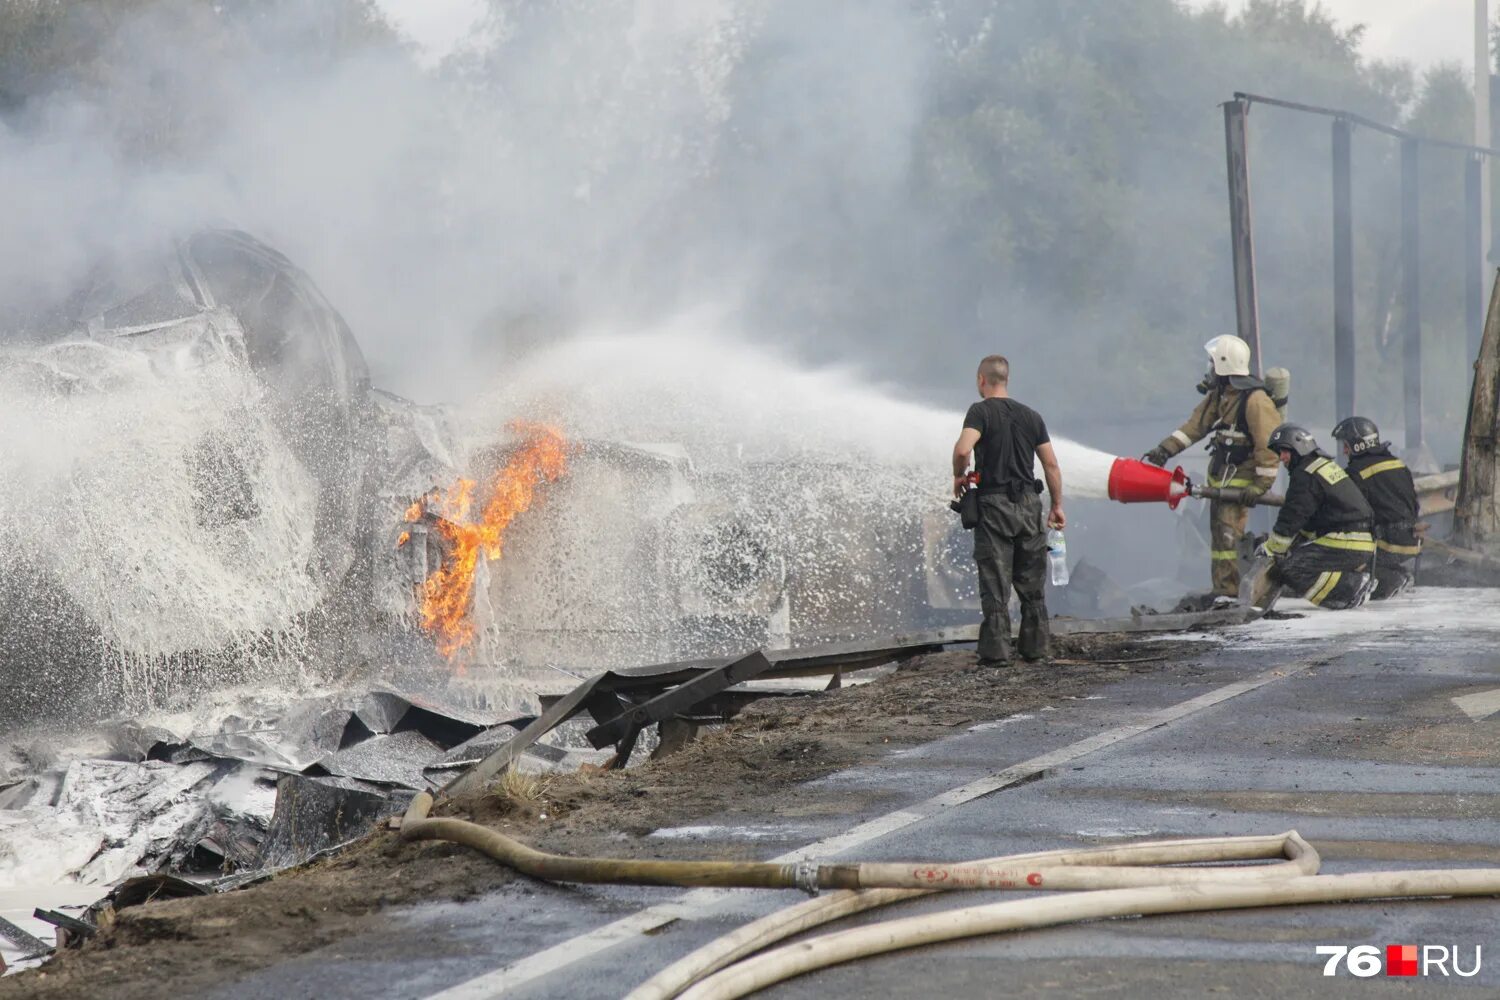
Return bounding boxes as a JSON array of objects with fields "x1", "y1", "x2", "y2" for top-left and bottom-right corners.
[{"x1": 974, "y1": 492, "x2": 1050, "y2": 666}]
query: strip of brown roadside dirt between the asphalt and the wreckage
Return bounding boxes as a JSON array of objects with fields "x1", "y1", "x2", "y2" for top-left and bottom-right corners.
[{"x1": 0, "y1": 636, "x2": 1205, "y2": 1000}]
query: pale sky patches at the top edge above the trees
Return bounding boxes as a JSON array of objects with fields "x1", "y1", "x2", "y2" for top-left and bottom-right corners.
[{"x1": 377, "y1": 0, "x2": 1482, "y2": 67}]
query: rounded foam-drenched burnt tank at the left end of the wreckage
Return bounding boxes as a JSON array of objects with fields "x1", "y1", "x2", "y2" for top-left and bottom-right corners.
[{"x1": 0, "y1": 231, "x2": 375, "y2": 723}]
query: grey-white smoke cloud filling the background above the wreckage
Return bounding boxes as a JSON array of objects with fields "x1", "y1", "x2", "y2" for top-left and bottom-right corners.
[{"x1": 0, "y1": 0, "x2": 1461, "y2": 437}]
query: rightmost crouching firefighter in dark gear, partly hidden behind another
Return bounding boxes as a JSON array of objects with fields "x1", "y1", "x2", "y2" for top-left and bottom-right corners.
[{"x1": 1334, "y1": 417, "x2": 1422, "y2": 601}]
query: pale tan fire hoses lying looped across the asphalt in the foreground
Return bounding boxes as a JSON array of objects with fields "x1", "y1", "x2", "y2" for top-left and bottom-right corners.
[{"x1": 401, "y1": 793, "x2": 1500, "y2": 1000}]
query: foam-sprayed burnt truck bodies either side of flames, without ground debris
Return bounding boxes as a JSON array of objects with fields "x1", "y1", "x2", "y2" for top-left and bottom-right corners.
[{"x1": 0, "y1": 229, "x2": 974, "y2": 726}]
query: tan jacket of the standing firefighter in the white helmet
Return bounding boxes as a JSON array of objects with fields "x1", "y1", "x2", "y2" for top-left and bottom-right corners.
[{"x1": 1160, "y1": 375, "x2": 1281, "y2": 492}]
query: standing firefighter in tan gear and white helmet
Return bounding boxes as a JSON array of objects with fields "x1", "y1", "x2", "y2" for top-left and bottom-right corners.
[{"x1": 1142, "y1": 336, "x2": 1281, "y2": 604}]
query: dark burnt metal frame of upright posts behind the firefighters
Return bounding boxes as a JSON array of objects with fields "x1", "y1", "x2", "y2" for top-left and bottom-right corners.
[{"x1": 1224, "y1": 91, "x2": 1500, "y2": 451}]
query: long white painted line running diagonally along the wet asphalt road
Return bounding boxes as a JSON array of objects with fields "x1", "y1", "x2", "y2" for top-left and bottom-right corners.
[{"x1": 426, "y1": 652, "x2": 1328, "y2": 1000}]
